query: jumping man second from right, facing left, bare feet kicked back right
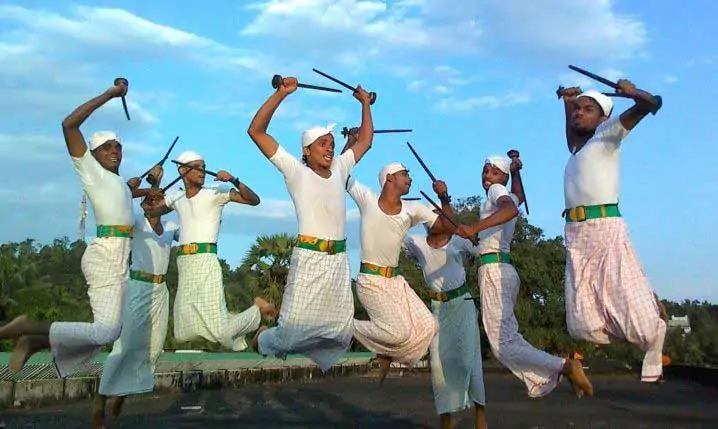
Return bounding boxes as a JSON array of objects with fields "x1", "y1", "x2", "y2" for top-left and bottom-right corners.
[{"x1": 457, "y1": 156, "x2": 593, "y2": 398}]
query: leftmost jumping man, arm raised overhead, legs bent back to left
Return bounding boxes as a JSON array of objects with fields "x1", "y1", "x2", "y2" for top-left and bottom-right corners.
[{"x1": 0, "y1": 77, "x2": 141, "y2": 378}]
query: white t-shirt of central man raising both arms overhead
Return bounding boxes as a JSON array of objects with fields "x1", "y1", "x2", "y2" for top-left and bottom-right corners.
[{"x1": 269, "y1": 146, "x2": 355, "y2": 240}]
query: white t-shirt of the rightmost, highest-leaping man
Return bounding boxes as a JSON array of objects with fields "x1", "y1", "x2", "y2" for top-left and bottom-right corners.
[{"x1": 563, "y1": 115, "x2": 628, "y2": 209}]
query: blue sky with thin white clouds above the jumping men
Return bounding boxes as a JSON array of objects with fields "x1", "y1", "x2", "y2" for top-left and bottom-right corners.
[{"x1": 0, "y1": 0, "x2": 718, "y2": 302}]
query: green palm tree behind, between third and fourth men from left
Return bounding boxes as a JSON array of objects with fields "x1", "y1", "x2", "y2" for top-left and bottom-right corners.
[{"x1": 240, "y1": 233, "x2": 297, "y2": 306}]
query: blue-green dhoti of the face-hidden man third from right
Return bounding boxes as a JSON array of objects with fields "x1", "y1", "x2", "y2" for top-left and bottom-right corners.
[{"x1": 429, "y1": 293, "x2": 486, "y2": 415}]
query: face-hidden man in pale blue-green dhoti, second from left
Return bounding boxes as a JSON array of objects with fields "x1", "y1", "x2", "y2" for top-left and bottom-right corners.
[{"x1": 92, "y1": 166, "x2": 179, "y2": 427}]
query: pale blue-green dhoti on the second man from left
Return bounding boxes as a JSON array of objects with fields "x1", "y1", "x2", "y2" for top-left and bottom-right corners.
[{"x1": 99, "y1": 280, "x2": 169, "y2": 396}]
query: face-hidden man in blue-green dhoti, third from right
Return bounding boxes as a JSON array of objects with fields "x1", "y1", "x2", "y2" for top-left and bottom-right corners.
[{"x1": 404, "y1": 206, "x2": 487, "y2": 429}]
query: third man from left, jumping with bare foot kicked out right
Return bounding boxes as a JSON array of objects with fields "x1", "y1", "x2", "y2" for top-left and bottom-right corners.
[{"x1": 146, "y1": 151, "x2": 276, "y2": 351}]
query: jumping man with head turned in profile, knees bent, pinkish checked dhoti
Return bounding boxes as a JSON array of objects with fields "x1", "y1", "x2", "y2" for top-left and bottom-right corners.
[{"x1": 347, "y1": 163, "x2": 454, "y2": 382}]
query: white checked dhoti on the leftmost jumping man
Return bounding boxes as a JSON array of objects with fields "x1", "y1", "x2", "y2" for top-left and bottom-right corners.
[{"x1": 49, "y1": 237, "x2": 131, "y2": 378}]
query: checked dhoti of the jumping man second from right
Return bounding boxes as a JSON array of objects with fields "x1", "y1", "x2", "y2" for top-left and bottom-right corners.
[{"x1": 479, "y1": 263, "x2": 564, "y2": 398}]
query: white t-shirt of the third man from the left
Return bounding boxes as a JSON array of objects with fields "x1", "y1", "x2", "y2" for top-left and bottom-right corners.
[{"x1": 165, "y1": 188, "x2": 231, "y2": 244}]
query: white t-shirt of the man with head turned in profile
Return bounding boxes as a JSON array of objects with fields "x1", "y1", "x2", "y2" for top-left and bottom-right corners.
[{"x1": 347, "y1": 178, "x2": 439, "y2": 267}]
